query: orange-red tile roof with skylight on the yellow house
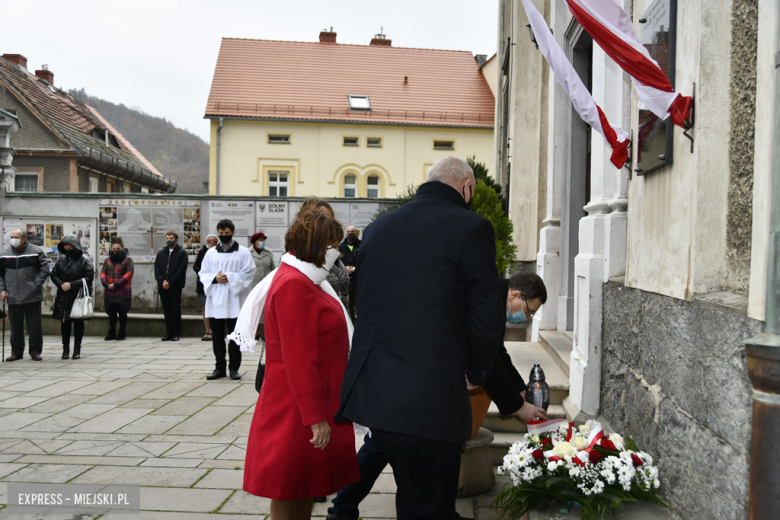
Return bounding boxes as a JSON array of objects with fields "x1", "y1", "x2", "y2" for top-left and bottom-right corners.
[{"x1": 206, "y1": 38, "x2": 495, "y2": 128}]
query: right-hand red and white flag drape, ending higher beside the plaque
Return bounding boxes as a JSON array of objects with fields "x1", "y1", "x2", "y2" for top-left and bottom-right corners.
[{"x1": 564, "y1": 0, "x2": 692, "y2": 128}]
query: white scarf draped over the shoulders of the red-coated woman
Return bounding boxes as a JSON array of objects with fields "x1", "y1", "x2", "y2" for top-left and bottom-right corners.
[{"x1": 227, "y1": 253, "x2": 355, "y2": 353}]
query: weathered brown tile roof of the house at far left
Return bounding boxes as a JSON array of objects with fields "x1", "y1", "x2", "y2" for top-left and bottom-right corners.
[{"x1": 0, "y1": 57, "x2": 163, "y2": 177}]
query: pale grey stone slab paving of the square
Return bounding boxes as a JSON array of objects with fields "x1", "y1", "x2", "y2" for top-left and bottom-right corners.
[{"x1": 0, "y1": 336, "x2": 672, "y2": 520}]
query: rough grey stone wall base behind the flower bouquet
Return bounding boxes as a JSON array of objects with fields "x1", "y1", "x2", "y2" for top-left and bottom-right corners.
[{"x1": 601, "y1": 281, "x2": 762, "y2": 520}]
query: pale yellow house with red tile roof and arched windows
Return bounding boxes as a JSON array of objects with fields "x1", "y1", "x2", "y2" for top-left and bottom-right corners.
[{"x1": 205, "y1": 32, "x2": 495, "y2": 198}]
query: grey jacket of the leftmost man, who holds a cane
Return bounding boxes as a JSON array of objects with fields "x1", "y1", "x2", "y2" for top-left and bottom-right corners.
[{"x1": 0, "y1": 242, "x2": 49, "y2": 305}]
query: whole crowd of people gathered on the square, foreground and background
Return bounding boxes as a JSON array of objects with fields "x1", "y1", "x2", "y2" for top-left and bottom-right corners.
[{"x1": 0, "y1": 157, "x2": 547, "y2": 520}]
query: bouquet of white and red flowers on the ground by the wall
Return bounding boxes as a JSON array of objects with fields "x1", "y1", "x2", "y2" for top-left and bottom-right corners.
[{"x1": 493, "y1": 419, "x2": 671, "y2": 519}]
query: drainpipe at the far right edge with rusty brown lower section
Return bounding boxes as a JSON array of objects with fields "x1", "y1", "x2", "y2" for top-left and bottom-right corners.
[{"x1": 745, "y1": 7, "x2": 780, "y2": 520}]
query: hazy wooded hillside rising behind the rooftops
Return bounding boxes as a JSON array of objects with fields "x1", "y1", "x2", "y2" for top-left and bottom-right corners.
[{"x1": 69, "y1": 89, "x2": 209, "y2": 193}]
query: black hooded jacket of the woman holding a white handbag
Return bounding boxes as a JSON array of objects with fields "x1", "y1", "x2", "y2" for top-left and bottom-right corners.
[{"x1": 51, "y1": 235, "x2": 95, "y2": 321}]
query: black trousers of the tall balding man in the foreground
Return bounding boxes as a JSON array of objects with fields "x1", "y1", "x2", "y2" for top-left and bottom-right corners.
[{"x1": 371, "y1": 430, "x2": 461, "y2": 520}]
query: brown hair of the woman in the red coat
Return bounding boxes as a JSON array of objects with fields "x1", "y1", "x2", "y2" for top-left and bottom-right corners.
[{"x1": 284, "y1": 211, "x2": 344, "y2": 267}]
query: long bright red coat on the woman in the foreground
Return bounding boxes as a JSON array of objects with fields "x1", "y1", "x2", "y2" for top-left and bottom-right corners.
[{"x1": 244, "y1": 264, "x2": 360, "y2": 500}]
